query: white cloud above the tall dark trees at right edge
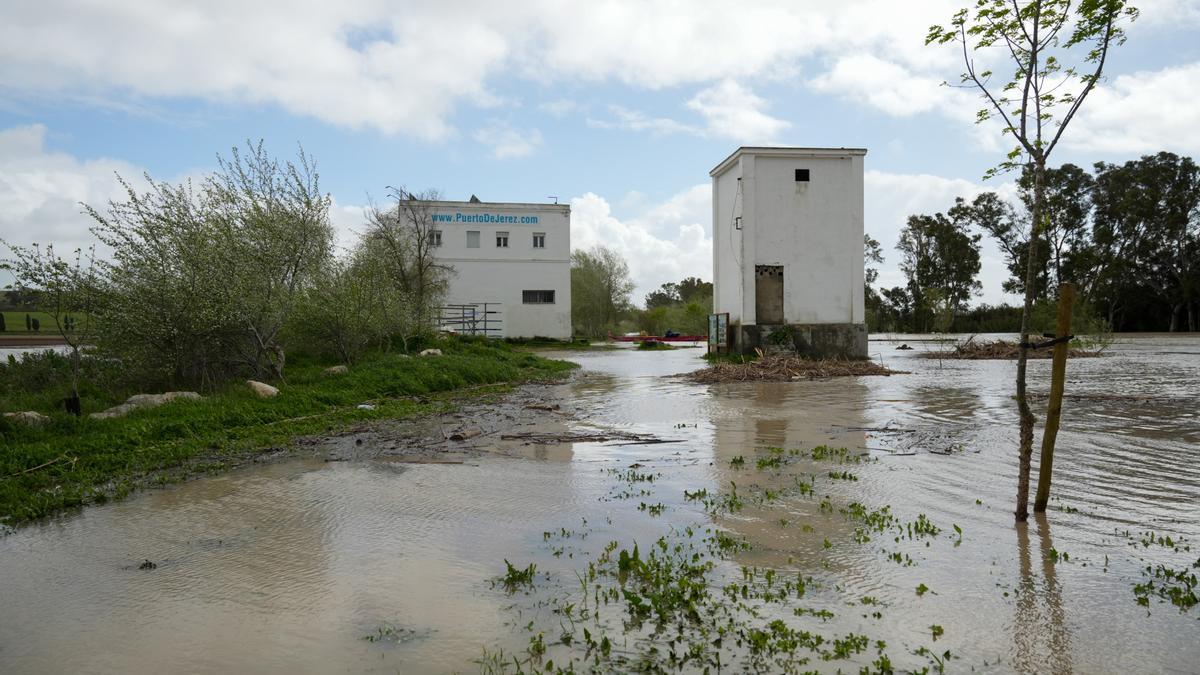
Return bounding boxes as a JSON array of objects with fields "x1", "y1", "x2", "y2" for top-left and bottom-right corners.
[{"x1": 1063, "y1": 61, "x2": 1200, "y2": 155}]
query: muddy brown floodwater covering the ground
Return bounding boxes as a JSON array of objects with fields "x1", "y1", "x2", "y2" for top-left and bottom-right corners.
[{"x1": 0, "y1": 335, "x2": 1200, "y2": 673}]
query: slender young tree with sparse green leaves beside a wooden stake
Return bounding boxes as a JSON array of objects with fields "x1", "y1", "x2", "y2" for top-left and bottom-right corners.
[{"x1": 925, "y1": 0, "x2": 1138, "y2": 521}]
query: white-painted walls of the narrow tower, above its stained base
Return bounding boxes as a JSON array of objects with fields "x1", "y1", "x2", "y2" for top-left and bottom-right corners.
[{"x1": 713, "y1": 149, "x2": 864, "y2": 324}]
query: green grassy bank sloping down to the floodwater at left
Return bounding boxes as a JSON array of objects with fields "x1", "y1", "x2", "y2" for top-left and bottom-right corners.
[{"x1": 0, "y1": 341, "x2": 574, "y2": 526}]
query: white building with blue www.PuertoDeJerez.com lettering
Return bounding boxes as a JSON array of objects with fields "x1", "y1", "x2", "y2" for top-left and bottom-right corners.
[{"x1": 430, "y1": 202, "x2": 571, "y2": 340}]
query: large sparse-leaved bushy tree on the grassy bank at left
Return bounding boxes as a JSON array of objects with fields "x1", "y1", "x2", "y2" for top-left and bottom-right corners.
[{"x1": 85, "y1": 143, "x2": 332, "y2": 387}]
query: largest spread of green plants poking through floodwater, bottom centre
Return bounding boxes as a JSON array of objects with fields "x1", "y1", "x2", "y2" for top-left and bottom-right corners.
[{"x1": 479, "y1": 446, "x2": 961, "y2": 674}]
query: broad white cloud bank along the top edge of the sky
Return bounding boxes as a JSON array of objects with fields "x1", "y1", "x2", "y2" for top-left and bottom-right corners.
[{"x1": 0, "y1": 0, "x2": 974, "y2": 139}]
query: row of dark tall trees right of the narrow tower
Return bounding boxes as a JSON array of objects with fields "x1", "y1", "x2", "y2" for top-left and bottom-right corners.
[{"x1": 864, "y1": 151, "x2": 1200, "y2": 333}]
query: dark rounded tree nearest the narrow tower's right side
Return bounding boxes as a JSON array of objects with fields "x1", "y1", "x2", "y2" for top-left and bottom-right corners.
[{"x1": 896, "y1": 208, "x2": 980, "y2": 330}]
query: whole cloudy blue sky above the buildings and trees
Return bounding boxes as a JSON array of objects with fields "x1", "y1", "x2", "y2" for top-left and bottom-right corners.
[{"x1": 0, "y1": 0, "x2": 1200, "y2": 304}]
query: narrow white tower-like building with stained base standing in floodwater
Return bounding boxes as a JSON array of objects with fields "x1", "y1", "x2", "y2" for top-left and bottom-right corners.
[{"x1": 709, "y1": 148, "x2": 866, "y2": 358}]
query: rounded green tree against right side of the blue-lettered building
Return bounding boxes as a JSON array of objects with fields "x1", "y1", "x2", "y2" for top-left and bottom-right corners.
[{"x1": 571, "y1": 245, "x2": 634, "y2": 338}]
